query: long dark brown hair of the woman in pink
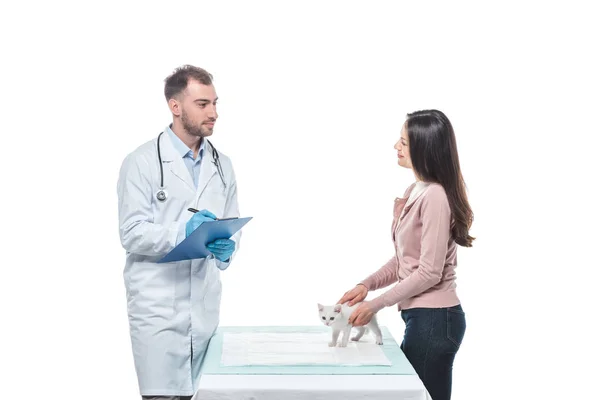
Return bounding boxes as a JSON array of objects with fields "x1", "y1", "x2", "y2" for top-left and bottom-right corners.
[{"x1": 406, "y1": 110, "x2": 475, "y2": 247}]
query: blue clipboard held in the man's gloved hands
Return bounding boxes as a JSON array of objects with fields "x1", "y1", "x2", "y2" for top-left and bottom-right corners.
[{"x1": 157, "y1": 217, "x2": 252, "y2": 263}]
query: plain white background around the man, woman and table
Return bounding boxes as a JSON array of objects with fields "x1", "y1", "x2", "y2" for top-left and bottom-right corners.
[{"x1": 0, "y1": 1, "x2": 600, "y2": 400}]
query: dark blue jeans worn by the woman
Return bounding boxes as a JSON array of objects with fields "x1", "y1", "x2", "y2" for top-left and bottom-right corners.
[{"x1": 400, "y1": 304, "x2": 467, "y2": 400}]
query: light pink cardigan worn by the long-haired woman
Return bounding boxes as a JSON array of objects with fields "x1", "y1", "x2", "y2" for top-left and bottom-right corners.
[{"x1": 360, "y1": 183, "x2": 460, "y2": 311}]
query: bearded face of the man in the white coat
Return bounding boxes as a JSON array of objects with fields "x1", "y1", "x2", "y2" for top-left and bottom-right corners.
[{"x1": 180, "y1": 80, "x2": 218, "y2": 137}]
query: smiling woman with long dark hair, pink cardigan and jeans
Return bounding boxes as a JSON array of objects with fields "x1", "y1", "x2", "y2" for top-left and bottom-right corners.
[{"x1": 338, "y1": 110, "x2": 474, "y2": 400}]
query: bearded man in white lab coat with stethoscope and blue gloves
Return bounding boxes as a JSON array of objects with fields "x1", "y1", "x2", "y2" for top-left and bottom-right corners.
[{"x1": 118, "y1": 65, "x2": 240, "y2": 400}]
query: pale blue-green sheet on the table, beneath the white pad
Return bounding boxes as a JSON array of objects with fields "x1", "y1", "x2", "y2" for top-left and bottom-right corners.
[{"x1": 201, "y1": 326, "x2": 416, "y2": 375}]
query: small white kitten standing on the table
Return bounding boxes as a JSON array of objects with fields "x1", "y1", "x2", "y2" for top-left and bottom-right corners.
[{"x1": 318, "y1": 303, "x2": 383, "y2": 347}]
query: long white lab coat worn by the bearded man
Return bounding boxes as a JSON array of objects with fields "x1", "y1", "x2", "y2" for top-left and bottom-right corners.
[{"x1": 118, "y1": 126, "x2": 241, "y2": 396}]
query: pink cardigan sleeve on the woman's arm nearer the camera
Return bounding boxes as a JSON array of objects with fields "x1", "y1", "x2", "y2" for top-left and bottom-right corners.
[{"x1": 371, "y1": 187, "x2": 452, "y2": 311}]
